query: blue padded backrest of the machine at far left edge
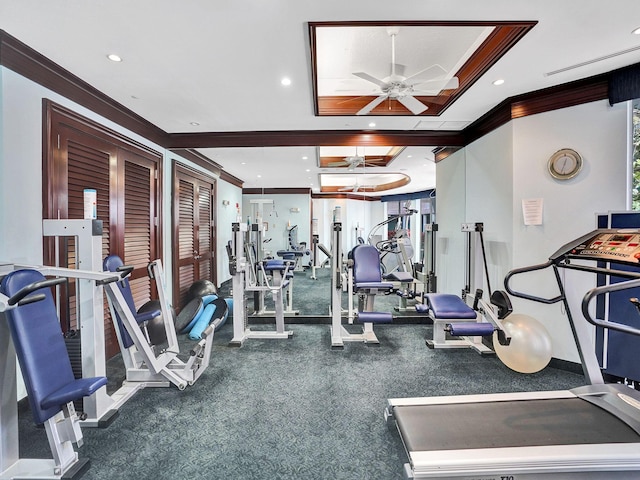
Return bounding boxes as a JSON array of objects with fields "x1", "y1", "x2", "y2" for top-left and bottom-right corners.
[{"x1": 0, "y1": 270, "x2": 74, "y2": 424}]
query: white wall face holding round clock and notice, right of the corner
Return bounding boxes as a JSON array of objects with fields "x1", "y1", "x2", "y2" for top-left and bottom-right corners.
[{"x1": 512, "y1": 100, "x2": 630, "y2": 362}]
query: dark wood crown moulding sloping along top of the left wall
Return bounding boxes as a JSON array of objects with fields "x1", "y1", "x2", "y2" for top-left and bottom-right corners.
[{"x1": 0, "y1": 30, "x2": 167, "y2": 145}]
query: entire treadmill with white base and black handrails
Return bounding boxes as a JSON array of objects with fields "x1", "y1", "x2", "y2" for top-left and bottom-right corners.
[{"x1": 385, "y1": 229, "x2": 640, "y2": 480}]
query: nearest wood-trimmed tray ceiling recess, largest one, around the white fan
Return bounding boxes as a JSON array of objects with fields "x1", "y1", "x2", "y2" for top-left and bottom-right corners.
[{"x1": 309, "y1": 21, "x2": 537, "y2": 116}]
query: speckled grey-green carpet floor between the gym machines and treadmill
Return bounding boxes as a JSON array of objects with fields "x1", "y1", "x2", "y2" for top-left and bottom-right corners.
[{"x1": 20, "y1": 321, "x2": 583, "y2": 480}]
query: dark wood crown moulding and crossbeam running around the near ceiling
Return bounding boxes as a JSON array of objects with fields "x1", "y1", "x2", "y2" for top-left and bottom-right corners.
[{"x1": 0, "y1": 28, "x2": 632, "y2": 171}]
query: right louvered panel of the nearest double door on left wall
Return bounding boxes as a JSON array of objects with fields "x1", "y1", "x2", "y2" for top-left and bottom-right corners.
[{"x1": 118, "y1": 152, "x2": 158, "y2": 308}]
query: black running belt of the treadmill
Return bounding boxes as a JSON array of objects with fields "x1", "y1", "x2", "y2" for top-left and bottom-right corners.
[{"x1": 394, "y1": 398, "x2": 640, "y2": 452}]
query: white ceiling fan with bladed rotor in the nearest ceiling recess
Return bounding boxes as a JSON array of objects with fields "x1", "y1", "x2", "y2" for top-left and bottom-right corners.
[{"x1": 354, "y1": 27, "x2": 459, "y2": 115}]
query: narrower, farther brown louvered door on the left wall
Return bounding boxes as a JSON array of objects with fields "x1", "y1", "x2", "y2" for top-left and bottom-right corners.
[{"x1": 173, "y1": 164, "x2": 217, "y2": 309}]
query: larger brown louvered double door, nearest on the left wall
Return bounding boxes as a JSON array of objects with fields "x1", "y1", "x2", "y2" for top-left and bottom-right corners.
[{"x1": 43, "y1": 103, "x2": 161, "y2": 358}]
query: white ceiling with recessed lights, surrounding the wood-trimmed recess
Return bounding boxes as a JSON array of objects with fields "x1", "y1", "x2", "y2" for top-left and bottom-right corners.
[{"x1": 0, "y1": 0, "x2": 640, "y2": 193}]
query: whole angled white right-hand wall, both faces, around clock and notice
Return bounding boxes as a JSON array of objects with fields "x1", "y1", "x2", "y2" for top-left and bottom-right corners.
[{"x1": 436, "y1": 101, "x2": 630, "y2": 362}]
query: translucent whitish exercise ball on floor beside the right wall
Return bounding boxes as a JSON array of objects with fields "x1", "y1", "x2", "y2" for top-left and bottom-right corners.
[{"x1": 493, "y1": 313, "x2": 553, "y2": 373}]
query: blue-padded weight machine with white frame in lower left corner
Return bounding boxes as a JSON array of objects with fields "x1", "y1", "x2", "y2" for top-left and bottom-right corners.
[{"x1": 0, "y1": 266, "x2": 107, "y2": 480}]
